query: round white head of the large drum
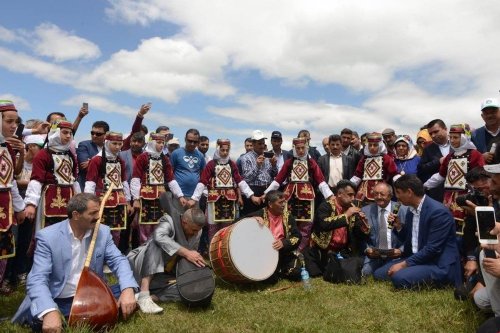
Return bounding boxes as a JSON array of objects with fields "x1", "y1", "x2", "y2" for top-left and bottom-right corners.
[{"x1": 229, "y1": 218, "x2": 279, "y2": 281}]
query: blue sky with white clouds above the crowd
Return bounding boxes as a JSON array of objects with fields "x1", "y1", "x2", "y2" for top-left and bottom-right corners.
[{"x1": 0, "y1": 0, "x2": 500, "y2": 156}]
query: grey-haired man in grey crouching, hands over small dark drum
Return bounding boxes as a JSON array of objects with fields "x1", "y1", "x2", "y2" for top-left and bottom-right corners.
[{"x1": 127, "y1": 208, "x2": 205, "y2": 313}]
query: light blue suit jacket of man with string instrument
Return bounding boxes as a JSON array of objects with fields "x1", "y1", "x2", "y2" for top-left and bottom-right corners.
[{"x1": 12, "y1": 219, "x2": 138, "y2": 323}]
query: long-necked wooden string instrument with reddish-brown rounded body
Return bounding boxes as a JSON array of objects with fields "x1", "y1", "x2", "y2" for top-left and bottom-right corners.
[{"x1": 68, "y1": 185, "x2": 118, "y2": 329}]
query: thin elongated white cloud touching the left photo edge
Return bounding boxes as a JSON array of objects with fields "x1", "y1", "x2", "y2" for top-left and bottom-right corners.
[{"x1": 0, "y1": 47, "x2": 78, "y2": 85}]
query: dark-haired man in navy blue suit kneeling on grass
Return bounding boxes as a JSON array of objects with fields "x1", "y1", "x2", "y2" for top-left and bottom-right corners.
[{"x1": 373, "y1": 175, "x2": 461, "y2": 288}]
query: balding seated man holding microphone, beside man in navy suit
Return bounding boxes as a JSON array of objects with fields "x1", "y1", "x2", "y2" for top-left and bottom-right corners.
[{"x1": 361, "y1": 183, "x2": 407, "y2": 276}]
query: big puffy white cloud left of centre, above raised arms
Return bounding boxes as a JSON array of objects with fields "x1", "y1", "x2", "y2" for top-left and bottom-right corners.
[{"x1": 78, "y1": 37, "x2": 234, "y2": 102}]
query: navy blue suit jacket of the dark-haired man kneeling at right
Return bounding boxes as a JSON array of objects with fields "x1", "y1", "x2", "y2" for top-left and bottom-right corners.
[{"x1": 399, "y1": 196, "x2": 460, "y2": 270}]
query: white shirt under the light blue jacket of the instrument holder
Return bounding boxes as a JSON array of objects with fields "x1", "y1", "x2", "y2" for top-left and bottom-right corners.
[{"x1": 58, "y1": 223, "x2": 91, "y2": 298}]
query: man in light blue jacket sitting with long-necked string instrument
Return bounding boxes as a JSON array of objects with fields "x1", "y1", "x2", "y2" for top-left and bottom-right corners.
[{"x1": 12, "y1": 193, "x2": 138, "y2": 331}]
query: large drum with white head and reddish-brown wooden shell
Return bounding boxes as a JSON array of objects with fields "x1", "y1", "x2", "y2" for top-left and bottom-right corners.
[{"x1": 210, "y1": 218, "x2": 279, "y2": 282}]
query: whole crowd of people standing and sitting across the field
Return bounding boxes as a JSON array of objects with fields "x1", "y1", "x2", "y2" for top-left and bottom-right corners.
[{"x1": 0, "y1": 98, "x2": 500, "y2": 329}]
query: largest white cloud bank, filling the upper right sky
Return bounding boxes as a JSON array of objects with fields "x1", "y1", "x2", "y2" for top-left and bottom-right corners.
[{"x1": 107, "y1": 0, "x2": 500, "y2": 91}]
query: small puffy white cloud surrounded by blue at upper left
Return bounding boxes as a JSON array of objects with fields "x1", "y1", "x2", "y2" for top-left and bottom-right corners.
[{"x1": 33, "y1": 23, "x2": 101, "y2": 62}]
